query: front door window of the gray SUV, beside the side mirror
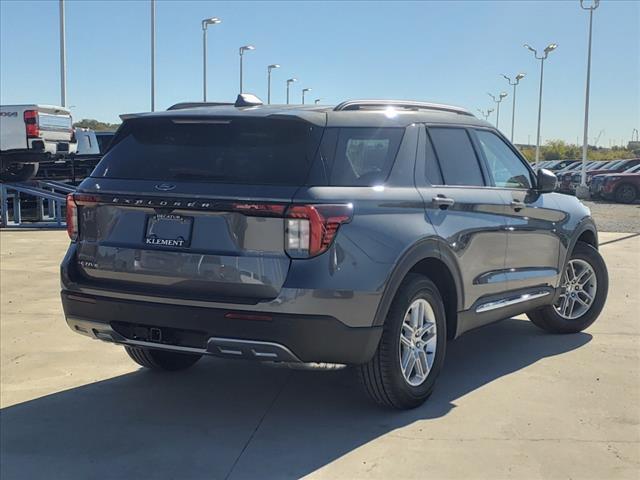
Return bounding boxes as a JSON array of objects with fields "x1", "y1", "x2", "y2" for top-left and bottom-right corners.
[{"x1": 476, "y1": 130, "x2": 532, "y2": 188}]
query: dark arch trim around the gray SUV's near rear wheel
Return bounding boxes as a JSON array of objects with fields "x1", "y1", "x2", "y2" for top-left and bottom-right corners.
[{"x1": 374, "y1": 238, "x2": 464, "y2": 338}]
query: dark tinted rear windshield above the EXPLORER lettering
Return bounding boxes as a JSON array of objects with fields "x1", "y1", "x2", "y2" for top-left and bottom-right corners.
[{"x1": 92, "y1": 118, "x2": 322, "y2": 185}]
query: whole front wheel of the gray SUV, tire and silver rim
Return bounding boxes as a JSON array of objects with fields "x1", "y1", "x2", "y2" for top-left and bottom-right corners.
[{"x1": 527, "y1": 242, "x2": 609, "y2": 333}]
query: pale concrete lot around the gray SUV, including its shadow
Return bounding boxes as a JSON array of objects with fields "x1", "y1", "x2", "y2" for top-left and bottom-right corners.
[{"x1": 0, "y1": 230, "x2": 640, "y2": 480}]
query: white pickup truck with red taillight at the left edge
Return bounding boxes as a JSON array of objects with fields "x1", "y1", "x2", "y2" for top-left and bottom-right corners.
[{"x1": 0, "y1": 105, "x2": 77, "y2": 182}]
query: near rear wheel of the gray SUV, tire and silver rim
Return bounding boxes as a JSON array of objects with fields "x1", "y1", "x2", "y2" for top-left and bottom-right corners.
[{"x1": 358, "y1": 274, "x2": 447, "y2": 409}]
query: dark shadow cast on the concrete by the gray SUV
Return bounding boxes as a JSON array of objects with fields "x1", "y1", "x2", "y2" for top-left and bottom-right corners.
[{"x1": 0, "y1": 319, "x2": 591, "y2": 480}]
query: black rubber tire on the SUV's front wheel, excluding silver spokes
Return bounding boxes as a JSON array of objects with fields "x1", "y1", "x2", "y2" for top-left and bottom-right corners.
[{"x1": 527, "y1": 242, "x2": 609, "y2": 333}]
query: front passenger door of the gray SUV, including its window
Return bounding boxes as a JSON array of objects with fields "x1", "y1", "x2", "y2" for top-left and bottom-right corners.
[{"x1": 472, "y1": 129, "x2": 567, "y2": 290}]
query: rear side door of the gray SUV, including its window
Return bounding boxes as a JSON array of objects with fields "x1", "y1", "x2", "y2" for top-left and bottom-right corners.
[{"x1": 416, "y1": 126, "x2": 507, "y2": 310}]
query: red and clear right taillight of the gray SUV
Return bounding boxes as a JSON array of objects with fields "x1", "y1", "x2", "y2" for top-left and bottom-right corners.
[{"x1": 285, "y1": 204, "x2": 353, "y2": 258}]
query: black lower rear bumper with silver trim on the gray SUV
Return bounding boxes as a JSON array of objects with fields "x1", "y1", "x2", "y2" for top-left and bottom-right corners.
[{"x1": 61, "y1": 290, "x2": 382, "y2": 364}]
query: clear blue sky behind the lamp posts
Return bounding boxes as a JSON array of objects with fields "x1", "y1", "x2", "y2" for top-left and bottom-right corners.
[{"x1": 0, "y1": 0, "x2": 640, "y2": 146}]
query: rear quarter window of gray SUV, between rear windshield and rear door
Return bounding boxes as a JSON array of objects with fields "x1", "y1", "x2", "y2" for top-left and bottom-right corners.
[{"x1": 322, "y1": 128, "x2": 404, "y2": 186}]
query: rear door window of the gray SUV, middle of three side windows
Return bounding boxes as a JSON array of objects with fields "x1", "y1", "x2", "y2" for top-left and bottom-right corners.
[{"x1": 427, "y1": 127, "x2": 485, "y2": 186}]
